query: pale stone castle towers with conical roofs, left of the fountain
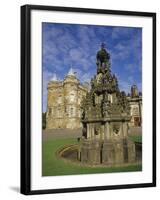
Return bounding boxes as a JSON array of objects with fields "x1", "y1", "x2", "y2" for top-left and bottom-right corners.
[{"x1": 46, "y1": 69, "x2": 88, "y2": 129}]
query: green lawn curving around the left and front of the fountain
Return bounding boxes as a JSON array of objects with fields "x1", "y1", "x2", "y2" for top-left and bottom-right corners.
[{"x1": 42, "y1": 139, "x2": 142, "y2": 176}]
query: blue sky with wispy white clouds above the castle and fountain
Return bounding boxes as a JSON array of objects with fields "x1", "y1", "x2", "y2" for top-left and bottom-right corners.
[{"x1": 42, "y1": 23, "x2": 142, "y2": 111}]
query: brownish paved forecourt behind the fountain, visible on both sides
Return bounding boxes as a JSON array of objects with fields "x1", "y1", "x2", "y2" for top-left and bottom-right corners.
[{"x1": 43, "y1": 127, "x2": 142, "y2": 141}]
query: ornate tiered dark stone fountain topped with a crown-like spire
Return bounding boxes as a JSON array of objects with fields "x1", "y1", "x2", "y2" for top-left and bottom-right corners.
[{"x1": 79, "y1": 44, "x2": 136, "y2": 166}]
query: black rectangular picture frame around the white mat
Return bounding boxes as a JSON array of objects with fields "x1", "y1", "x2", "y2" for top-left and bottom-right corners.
[{"x1": 20, "y1": 5, "x2": 156, "y2": 195}]
